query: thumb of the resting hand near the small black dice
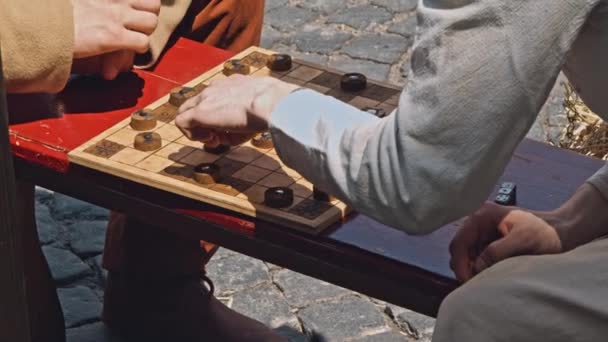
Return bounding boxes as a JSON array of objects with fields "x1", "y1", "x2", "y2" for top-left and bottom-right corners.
[{"x1": 474, "y1": 222, "x2": 530, "y2": 273}]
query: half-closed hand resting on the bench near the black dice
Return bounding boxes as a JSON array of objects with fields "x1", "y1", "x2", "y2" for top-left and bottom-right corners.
[{"x1": 450, "y1": 202, "x2": 563, "y2": 281}]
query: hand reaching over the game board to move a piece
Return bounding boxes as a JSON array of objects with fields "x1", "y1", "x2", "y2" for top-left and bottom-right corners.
[{"x1": 175, "y1": 75, "x2": 298, "y2": 146}]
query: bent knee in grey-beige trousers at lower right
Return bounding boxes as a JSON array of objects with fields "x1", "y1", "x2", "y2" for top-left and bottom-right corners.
[{"x1": 433, "y1": 239, "x2": 608, "y2": 342}]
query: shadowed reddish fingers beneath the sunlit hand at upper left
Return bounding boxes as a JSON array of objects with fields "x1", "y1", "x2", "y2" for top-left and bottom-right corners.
[{"x1": 72, "y1": 50, "x2": 135, "y2": 80}]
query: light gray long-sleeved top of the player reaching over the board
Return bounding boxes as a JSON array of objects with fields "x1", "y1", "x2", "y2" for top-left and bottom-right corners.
[{"x1": 271, "y1": 0, "x2": 608, "y2": 234}]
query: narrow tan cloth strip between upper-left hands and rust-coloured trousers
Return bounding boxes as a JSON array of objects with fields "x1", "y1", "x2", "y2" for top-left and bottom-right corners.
[{"x1": 136, "y1": 0, "x2": 192, "y2": 69}]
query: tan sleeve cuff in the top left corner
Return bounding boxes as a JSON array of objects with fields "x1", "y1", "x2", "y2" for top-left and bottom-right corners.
[{"x1": 0, "y1": 0, "x2": 74, "y2": 93}]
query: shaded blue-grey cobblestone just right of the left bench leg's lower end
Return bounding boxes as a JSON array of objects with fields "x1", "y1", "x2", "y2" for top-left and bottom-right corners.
[{"x1": 57, "y1": 286, "x2": 101, "y2": 328}]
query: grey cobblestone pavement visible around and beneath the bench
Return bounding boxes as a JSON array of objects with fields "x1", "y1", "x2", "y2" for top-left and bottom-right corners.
[{"x1": 44, "y1": 0, "x2": 564, "y2": 342}]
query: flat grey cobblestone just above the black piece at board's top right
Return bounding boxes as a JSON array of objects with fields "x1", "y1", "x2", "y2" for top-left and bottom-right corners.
[{"x1": 342, "y1": 33, "x2": 412, "y2": 64}]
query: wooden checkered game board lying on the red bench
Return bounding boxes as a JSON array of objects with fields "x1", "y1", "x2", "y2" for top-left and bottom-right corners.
[{"x1": 69, "y1": 47, "x2": 400, "y2": 233}]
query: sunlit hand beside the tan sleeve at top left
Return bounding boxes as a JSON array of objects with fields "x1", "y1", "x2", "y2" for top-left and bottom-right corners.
[{"x1": 72, "y1": 0, "x2": 161, "y2": 59}]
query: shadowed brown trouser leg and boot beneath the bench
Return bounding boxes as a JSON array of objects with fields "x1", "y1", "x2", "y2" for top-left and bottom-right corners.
[{"x1": 103, "y1": 213, "x2": 283, "y2": 342}]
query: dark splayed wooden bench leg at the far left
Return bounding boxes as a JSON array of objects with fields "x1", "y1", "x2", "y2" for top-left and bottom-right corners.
[{"x1": 17, "y1": 182, "x2": 65, "y2": 342}]
